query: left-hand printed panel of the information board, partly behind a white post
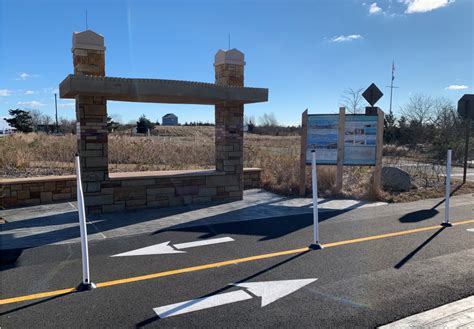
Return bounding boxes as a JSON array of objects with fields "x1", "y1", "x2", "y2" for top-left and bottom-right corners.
[{"x1": 306, "y1": 114, "x2": 339, "y2": 164}]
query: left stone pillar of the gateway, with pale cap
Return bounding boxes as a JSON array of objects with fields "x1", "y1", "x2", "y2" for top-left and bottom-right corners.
[{"x1": 72, "y1": 30, "x2": 109, "y2": 212}]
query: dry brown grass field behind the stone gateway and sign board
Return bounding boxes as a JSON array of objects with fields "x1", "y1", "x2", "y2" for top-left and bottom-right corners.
[{"x1": 0, "y1": 126, "x2": 474, "y2": 202}]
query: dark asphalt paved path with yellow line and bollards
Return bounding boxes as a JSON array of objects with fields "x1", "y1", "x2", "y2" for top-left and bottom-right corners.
[{"x1": 0, "y1": 196, "x2": 474, "y2": 328}]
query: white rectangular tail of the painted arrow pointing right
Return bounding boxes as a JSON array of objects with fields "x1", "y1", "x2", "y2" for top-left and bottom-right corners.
[{"x1": 153, "y1": 290, "x2": 252, "y2": 319}]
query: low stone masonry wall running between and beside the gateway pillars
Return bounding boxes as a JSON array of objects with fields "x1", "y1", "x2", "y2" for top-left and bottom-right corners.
[{"x1": 0, "y1": 168, "x2": 261, "y2": 212}]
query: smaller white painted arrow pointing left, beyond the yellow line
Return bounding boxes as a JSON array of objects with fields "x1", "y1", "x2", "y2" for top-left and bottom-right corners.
[{"x1": 111, "y1": 236, "x2": 234, "y2": 257}]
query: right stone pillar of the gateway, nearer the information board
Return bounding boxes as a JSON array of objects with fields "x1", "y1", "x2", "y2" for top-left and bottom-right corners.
[{"x1": 214, "y1": 49, "x2": 245, "y2": 199}]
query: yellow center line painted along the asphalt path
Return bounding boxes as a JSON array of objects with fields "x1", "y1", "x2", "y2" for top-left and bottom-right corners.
[{"x1": 0, "y1": 219, "x2": 474, "y2": 305}]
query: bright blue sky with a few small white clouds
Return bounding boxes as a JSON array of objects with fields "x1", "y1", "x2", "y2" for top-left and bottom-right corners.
[{"x1": 0, "y1": 0, "x2": 474, "y2": 124}]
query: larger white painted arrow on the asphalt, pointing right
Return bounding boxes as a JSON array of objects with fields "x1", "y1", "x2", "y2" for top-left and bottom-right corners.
[{"x1": 153, "y1": 278, "x2": 317, "y2": 319}]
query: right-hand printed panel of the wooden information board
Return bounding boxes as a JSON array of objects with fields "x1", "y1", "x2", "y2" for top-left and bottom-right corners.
[{"x1": 344, "y1": 115, "x2": 377, "y2": 166}]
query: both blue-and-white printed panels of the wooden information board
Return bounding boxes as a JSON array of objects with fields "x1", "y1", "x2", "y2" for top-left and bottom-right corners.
[{"x1": 306, "y1": 114, "x2": 377, "y2": 166}]
